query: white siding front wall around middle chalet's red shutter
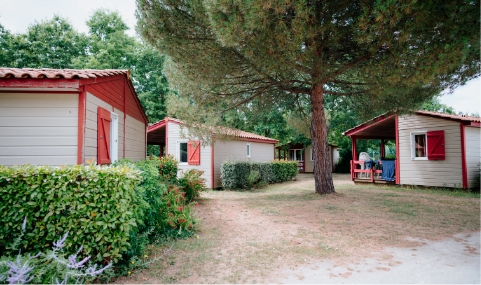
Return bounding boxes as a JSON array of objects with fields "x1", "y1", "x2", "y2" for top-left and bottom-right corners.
[{"x1": 167, "y1": 122, "x2": 212, "y2": 188}]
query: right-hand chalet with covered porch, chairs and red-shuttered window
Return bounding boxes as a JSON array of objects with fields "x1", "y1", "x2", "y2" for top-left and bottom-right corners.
[{"x1": 344, "y1": 111, "x2": 481, "y2": 189}]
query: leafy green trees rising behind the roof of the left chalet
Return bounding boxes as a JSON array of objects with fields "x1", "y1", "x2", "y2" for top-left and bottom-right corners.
[{"x1": 0, "y1": 9, "x2": 170, "y2": 122}]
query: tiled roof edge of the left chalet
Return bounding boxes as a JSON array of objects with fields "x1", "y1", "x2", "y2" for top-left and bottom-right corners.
[{"x1": 0, "y1": 67, "x2": 130, "y2": 79}]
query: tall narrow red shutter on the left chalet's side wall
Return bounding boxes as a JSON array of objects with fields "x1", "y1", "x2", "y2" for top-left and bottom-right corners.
[{"x1": 97, "y1": 107, "x2": 112, "y2": 164}]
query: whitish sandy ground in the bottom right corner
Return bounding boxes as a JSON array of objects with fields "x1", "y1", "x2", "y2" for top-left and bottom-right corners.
[{"x1": 279, "y1": 232, "x2": 480, "y2": 284}]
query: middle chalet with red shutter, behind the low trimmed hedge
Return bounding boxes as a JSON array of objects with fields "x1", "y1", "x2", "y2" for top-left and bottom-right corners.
[{"x1": 147, "y1": 118, "x2": 278, "y2": 189}]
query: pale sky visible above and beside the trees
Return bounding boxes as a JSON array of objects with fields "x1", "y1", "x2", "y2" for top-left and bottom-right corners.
[{"x1": 0, "y1": 0, "x2": 481, "y2": 114}]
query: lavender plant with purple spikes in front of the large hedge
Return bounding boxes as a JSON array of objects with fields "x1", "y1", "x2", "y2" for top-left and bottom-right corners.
[{"x1": 0, "y1": 219, "x2": 112, "y2": 284}]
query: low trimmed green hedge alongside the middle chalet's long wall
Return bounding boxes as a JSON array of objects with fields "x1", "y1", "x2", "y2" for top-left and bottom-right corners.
[{"x1": 220, "y1": 160, "x2": 298, "y2": 189}]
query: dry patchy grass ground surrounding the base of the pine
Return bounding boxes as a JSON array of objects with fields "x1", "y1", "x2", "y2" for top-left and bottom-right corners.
[{"x1": 117, "y1": 174, "x2": 480, "y2": 283}]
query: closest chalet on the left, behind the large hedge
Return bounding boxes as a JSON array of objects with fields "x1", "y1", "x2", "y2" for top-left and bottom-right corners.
[{"x1": 0, "y1": 68, "x2": 148, "y2": 166}]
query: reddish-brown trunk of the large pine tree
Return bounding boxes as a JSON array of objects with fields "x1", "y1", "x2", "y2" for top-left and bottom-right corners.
[{"x1": 311, "y1": 85, "x2": 335, "y2": 195}]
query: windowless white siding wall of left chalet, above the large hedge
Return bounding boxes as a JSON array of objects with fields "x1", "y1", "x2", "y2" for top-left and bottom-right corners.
[{"x1": 0, "y1": 93, "x2": 78, "y2": 165}]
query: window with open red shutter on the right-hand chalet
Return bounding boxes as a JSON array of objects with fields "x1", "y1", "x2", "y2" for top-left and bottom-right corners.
[{"x1": 411, "y1": 131, "x2": 446, "y2": 160}]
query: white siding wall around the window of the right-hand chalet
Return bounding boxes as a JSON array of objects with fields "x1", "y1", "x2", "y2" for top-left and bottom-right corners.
[{"x1": 398, "y1": 115, "x2": 463, "y2": 187}]
